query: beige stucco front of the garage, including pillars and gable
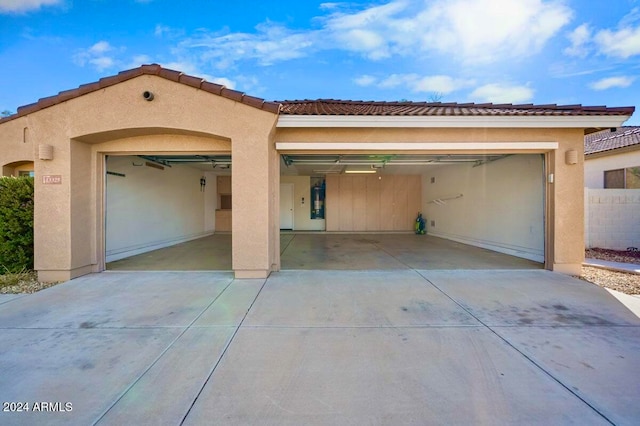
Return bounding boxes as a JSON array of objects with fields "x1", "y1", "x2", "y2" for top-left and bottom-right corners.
[{"x1": 0, "y1": 70, "x2": 632, "y2": 280}]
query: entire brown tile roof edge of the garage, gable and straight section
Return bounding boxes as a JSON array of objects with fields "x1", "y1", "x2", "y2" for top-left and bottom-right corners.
[{"x1": 0, "y1": 64, "x2": 635, "y2": 123}]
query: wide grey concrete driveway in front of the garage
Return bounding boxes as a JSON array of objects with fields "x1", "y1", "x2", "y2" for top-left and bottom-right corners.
[{"x1": 0, "y1": 270, "x2": 640, "y2": 425}]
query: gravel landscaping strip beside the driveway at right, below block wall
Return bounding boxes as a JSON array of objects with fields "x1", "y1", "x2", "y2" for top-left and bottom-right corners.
[{"x1": 580, "y1": 248, "x2": 640, "y2": 295}]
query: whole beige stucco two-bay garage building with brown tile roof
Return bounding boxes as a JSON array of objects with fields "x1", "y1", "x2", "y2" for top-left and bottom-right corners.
[{"x1": 0, "y1": 64, "x2": 634, "y2": 281}]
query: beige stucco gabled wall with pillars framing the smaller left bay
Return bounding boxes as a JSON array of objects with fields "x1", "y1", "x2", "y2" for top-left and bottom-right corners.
[{"x1": 0, "y1": 75, "x2": 278, "y2": 280}]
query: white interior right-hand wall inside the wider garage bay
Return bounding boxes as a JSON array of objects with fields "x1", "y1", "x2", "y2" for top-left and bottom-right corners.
[{"x1": 422, "y1": 154, "x2": 544, "y2": 262}]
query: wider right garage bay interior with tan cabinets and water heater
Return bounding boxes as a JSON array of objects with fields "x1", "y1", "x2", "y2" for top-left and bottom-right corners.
[{"x1": 281, "y1": 154, "x2": 545, "y2": 269}]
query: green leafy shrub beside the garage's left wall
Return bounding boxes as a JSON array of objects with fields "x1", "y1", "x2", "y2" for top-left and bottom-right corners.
[{"x1": 0, "y1": 177, "x2": 33, "y2": 274}]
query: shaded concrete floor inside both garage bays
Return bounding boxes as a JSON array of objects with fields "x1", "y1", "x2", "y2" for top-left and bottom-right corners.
[{"x1": 107, "y1": 232, "x2": 542, "y2": 271}]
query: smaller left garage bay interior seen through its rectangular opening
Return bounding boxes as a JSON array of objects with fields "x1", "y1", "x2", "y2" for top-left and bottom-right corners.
[{"x1": 105, "y1": 155, "x2": 231, "y2": 270}]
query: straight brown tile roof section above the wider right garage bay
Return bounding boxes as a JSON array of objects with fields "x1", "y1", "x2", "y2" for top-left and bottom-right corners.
[{"x1": 280, "y1": 99, "x2": 635, "y2": 116}]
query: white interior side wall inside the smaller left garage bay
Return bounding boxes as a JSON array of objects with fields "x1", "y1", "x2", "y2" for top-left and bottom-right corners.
[{"x1": 106, "y1": 156, "x2": 215, "y2": 261}]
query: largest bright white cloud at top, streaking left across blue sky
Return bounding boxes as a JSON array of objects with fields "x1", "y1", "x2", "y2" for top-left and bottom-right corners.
[{"x1": 164, "y1": 0, "x2": 572, "y2": 72}]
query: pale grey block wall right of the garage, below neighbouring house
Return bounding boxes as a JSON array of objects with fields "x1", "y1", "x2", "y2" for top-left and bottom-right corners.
[{"x1": 585, "y1": 188, "x2": 640, "y2": 250}]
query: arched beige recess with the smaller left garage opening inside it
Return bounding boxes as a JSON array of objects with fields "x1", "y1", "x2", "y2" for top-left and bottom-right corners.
[{"x1": 74, "y1": 128, "x2": 232, "y2": 271}]
